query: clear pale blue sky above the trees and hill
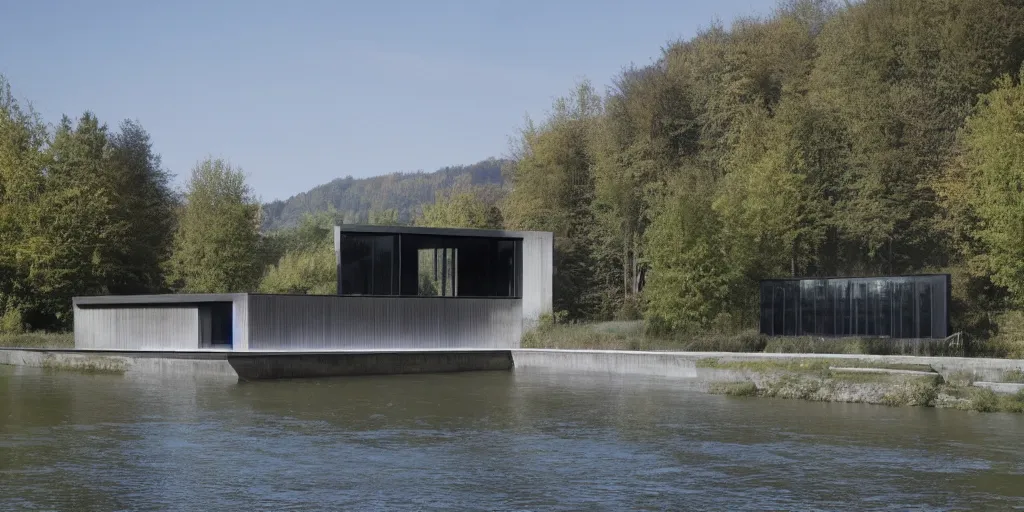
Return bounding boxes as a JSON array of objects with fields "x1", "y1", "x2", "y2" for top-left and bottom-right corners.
[{"x1": 0, "y1": 0, "x2": 776, "y2": 201}]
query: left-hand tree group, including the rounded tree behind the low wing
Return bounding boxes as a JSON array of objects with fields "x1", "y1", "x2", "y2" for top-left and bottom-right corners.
[{"x1": 0, "y1": 78, "x2": 269, "y2": 333}]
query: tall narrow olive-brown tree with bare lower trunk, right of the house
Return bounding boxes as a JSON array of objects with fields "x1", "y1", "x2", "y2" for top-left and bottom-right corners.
[{"x1": 593, "y1": 66, "x2": 699, "y2": 317}]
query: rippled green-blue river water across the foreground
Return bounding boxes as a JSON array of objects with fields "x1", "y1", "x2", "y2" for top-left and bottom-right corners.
[{"x1": 0, "y1": 366, "x2": 1024, "y2": 510}]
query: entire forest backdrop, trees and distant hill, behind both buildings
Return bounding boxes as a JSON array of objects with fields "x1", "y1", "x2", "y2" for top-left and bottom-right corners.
[{"x1": 0, "y1": 0, "x2": 1024, "y2": 352}]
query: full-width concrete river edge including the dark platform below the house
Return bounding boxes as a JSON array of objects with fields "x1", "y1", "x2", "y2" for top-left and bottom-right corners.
[{"x1": 6, "y1": 348, "x2": 1024, "y2": 413}]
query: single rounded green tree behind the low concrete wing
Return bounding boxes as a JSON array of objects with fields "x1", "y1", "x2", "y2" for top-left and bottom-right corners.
[{"x1": 168, "y1": 159, "x2": 263, "y2": 293}]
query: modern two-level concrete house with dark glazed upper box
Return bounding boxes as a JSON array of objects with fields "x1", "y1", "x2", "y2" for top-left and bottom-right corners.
[{"x1": 74, "y1": 225, "x2": 552, "y2": 353}]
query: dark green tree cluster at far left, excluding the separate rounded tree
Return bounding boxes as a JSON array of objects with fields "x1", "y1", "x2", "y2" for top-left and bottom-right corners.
[{"x1": 0, "y1": 80, "x2": 178, "y2": 331}]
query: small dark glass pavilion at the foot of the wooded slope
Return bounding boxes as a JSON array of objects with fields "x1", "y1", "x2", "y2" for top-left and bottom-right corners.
[{"x1": 760, "y1": 274, "x2": 950, "y2": 338}]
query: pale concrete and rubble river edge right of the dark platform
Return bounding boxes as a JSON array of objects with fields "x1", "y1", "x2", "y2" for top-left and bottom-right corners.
[{"x1": 512, "y1": 349, "x2": 1024, "y2": 413}]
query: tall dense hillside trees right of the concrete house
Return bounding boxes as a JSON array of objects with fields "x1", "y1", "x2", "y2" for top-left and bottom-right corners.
[{"x1": 503, "y1": 0, "x2": 1024, "y2": 342}]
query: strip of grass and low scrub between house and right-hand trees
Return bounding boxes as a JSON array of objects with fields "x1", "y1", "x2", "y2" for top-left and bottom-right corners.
[{"x1": 522, "y1": 322, "x2": 1013, "y2": 357}]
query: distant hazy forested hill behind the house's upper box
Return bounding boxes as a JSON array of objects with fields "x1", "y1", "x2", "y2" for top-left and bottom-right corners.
[{"x1": 263, "y1": 158, "x2": 505, "y2": 230}]
